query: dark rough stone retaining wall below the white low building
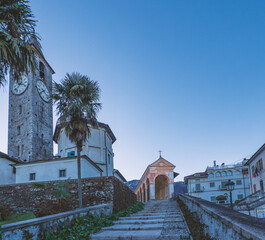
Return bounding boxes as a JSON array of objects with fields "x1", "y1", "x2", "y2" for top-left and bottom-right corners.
[{"x1": 0, "y1": 177, "x2": 136, "y2": 212}]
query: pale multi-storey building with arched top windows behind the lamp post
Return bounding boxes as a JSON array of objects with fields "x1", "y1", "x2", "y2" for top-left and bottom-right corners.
[{"x1": 184, "y1": 160, "x2": 250, "y2": 204}]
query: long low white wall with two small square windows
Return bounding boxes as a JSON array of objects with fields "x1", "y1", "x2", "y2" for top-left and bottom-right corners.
[{"x1": 16, "y1": 159, "x2": 100, "y2": 183}]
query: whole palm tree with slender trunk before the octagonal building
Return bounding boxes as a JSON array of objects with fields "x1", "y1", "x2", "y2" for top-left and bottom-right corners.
[{"x1": 51, "y1": 73, "x2": 101, "y2": 208}]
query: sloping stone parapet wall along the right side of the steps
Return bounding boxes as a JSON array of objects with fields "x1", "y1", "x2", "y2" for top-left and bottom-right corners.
[{"x1": 179, "y1": 194, "x2": 265, "y2": 240}]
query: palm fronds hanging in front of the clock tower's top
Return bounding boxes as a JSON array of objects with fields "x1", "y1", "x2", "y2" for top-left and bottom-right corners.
[{"x1": 0, "y1": 0, "x2": 41, "y2": 87}]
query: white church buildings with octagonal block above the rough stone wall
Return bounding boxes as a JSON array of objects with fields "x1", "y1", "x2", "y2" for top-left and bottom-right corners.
[{"x1": 0, "y1": 123, "x2": 126, "y2": 185}]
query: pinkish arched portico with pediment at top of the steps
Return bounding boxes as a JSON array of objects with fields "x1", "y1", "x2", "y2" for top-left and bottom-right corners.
[{"x1": 134, "y1": 156, "x2": 179, "y2": 202}]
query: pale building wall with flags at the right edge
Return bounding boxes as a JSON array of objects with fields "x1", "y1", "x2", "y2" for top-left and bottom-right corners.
[{"x1": 249, "y1": 151, "x2": 265, "y2": 193}]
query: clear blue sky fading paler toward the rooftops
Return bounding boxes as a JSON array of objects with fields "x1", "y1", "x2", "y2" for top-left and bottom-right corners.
[{"x1": 0, "y1": 0, "x2": 265, "y2": 180}]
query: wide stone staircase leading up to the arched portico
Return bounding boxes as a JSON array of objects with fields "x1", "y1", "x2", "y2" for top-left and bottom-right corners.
[{"x1": 91, "y1": 200, "x2": 192, "y2": 240}]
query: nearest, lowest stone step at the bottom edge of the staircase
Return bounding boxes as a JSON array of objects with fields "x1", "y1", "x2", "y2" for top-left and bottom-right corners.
[{"x1": 90, "y1": 230, "x2": 190, "y2": 240}]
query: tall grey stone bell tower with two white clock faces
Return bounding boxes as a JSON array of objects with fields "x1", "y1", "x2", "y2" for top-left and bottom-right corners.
[{"x1": 8, "y1": 43, "x2": 54, "y2": 162}]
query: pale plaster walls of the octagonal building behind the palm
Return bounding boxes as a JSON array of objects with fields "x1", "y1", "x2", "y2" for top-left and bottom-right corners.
[{"x1": 58, "y1": 128, "x2": 114, "y2": 176}]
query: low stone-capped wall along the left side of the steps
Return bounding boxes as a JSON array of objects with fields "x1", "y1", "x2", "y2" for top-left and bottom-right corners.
[{"x1": 1, "y1": 204, "x2": 113, "y2": 240}]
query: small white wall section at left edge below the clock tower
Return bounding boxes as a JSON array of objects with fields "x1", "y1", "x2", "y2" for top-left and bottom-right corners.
[{"x1": 0, "y1": 158, "x2": 16, "y2": 185}]
